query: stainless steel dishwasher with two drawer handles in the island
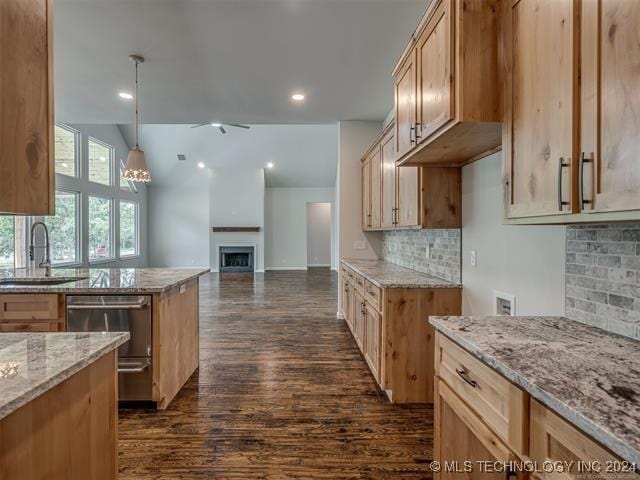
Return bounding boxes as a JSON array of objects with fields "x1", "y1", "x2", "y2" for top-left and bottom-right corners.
[{"x1": 67, "y1": 295, "x2": 153, "y2": 402}]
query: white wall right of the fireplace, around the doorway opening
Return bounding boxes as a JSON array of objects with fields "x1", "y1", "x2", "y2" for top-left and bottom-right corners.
[{"x1": 265, "y1": 188, "x2": 335, "y2": 270}]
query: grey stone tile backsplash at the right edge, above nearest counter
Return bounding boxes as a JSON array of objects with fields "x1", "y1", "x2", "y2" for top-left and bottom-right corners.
[{"x1": 566, "y1": 222, "x2": 640, "y2": 340}]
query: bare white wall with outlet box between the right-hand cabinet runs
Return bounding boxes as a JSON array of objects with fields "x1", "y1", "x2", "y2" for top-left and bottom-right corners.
[{"x1": 462, "y1": 153, "x2": 566, "y2": 315}]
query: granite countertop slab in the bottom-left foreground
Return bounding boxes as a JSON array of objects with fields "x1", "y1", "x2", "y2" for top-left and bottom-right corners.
[{"x1": 0, "y1": 332, "x2": 129, "y2": 419}]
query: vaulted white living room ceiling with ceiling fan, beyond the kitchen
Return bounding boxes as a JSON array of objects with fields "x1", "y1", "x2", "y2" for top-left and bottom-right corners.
[{"x1": 120, "y1": 125, "x2": 338, "y2": 187}]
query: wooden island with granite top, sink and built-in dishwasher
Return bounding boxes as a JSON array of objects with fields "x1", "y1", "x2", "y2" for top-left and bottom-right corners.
[{"x1": 0, "y1": 268, "x2": 209, "y2": 409}]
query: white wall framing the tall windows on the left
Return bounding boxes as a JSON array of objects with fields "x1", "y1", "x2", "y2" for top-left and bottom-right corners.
[{"x1": 56, "y1": 124, "x2": 148, "y2": 268}]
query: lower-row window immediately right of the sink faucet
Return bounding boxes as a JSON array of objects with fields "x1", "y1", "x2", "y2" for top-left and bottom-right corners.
[{"x1": 45, "y1": 191, "x2": 80, "y2": 264}]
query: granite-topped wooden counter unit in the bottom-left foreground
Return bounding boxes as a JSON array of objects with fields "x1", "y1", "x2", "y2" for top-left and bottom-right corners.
[{"x1": 0, "y1": 333, "x2": 129, "y2": 480}]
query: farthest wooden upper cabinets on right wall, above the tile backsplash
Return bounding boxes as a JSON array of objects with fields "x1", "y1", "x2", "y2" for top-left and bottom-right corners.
[{"x1": 362, "y1": 123, "x2": 462, "y2": 230}]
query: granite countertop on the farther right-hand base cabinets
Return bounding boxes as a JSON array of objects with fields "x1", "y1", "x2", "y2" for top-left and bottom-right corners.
[{"x1": 342, "y1": 260, "x2": 462, "y2": 288}]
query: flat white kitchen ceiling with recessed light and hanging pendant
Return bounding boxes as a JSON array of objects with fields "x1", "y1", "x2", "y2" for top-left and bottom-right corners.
[{"x1": 54, "y1": 0, "x2": 428, "y2": 125}]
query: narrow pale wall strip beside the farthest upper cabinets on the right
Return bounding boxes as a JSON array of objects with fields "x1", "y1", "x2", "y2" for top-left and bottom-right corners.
[{"x1": 336, "y1": 121, "x2": 382, "y2": 259}]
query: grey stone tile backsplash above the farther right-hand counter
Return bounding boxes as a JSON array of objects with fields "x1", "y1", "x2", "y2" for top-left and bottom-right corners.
[{"x1": 383, "y1": 229, "x2": 461, "y2": 282}]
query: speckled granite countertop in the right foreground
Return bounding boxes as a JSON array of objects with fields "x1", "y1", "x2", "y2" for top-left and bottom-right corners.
[{"x1": 429, "y1": 316, "x2": 640, "y2": 464}]
